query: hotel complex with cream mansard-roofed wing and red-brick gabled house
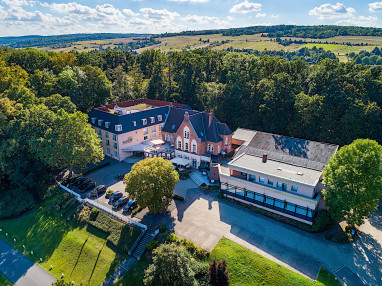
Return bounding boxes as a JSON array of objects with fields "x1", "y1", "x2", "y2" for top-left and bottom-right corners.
[{"x1": 89, "y1": 99, "x2": 232, "y2": 168}]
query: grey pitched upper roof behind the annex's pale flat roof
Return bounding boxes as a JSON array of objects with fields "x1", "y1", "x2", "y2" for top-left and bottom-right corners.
[{"x1": 235, "y1": 130, "x2": 338, "y2": 171}]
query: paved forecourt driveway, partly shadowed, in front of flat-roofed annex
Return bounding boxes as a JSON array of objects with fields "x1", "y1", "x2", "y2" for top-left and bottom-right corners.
[{"x1": 162, "y1": 180, "x2": 382, "y2": 285}]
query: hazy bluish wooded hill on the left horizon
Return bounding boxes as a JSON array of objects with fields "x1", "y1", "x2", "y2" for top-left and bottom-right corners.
[{"x1": 0, "y1": 33, "x2": 150, "y2": 48}]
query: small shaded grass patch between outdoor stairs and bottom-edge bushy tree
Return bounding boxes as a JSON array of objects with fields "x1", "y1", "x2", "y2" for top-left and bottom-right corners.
[{"x1": 115, "y1": 257, "x2": 152, "y2": 286}]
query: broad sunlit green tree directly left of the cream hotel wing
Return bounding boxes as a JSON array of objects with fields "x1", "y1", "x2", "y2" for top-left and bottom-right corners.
[{"x1": 33, "y1": 109, "x2": 104, "y2": 171}]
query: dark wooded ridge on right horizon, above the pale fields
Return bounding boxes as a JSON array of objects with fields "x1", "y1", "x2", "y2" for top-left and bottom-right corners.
[{"x1": 161, "y1": 25, "x2": 382, "y2": 39}]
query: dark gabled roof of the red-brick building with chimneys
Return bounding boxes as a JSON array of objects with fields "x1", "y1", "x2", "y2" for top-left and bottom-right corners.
[{"x1": 162, "y1": 107, "x2": 232, "y2": 143}]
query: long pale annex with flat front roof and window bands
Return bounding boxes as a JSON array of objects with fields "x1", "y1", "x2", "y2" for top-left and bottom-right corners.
[{"x1": 219, "y1": 128, "x2": 338, "y2": 224}]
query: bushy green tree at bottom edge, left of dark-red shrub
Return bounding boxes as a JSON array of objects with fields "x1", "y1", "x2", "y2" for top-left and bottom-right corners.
[{"x1": 143, "y1": 243, "x2": 196, "y2": 286}]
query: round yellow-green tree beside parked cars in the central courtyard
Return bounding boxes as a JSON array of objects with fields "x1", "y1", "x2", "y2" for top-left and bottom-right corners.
[{"x1": 124, "y1": 158, "x2": 179, "y2": 213}]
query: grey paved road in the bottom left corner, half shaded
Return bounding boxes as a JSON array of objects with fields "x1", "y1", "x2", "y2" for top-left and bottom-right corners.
[{"x1": 0, "y1": 239, "x2": 56, "y2": 286}]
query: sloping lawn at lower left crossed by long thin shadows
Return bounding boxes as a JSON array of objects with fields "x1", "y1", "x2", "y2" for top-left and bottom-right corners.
[{"x1": 0, "y1": 208, "x2": 126, "y2": 285}]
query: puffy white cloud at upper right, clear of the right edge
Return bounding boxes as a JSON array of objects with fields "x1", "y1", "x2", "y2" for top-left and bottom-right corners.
[{"x1": 309, "y1": 2, "x2": 355, "y2": 20}]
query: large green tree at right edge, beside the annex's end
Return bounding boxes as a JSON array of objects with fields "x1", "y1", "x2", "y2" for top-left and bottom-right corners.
[{"x1": 322, "y1": 139, "x2": 382, "y2": 226}]
